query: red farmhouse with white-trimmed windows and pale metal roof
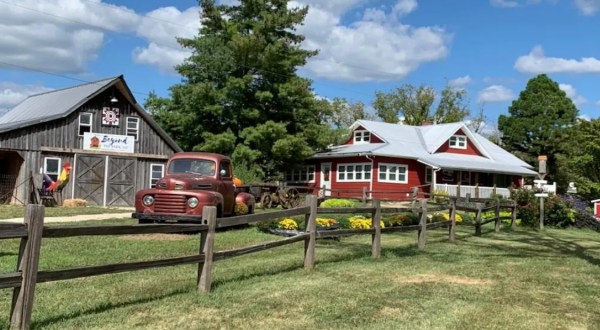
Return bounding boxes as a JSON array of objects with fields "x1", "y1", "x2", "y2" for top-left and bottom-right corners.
[{"x1": 286, "y1": 120, "x2": 536, "y2": 199}]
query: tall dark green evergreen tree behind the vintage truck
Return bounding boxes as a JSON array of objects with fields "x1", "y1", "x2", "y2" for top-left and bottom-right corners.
[{"x1": 145, "y1": 0, "x2": 329, "y2": 180}]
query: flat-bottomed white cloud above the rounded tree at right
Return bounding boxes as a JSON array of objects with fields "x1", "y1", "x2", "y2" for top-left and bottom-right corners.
[{"x1": 515, "y1": 46, "x2": 600, "y2": 74}]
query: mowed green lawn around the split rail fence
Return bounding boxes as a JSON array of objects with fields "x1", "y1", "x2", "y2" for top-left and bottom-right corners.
[{"x1": 0, "y1": 220, "x2": 600, "y2": 329}]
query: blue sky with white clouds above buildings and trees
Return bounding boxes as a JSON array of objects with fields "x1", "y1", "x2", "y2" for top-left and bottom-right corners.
[{"x1": 0, "y1": 0, "x2": 600, "y2": 127}]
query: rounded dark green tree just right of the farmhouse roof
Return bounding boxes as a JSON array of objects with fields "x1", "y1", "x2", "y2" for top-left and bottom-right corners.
[{"x1": 498, "y1": 74, "x2": 578, "y2": 179}]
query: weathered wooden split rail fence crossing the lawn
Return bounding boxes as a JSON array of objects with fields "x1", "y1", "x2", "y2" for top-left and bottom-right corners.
[{"x1": 0, "y1": 195, "x2": 515, "y2": 329}]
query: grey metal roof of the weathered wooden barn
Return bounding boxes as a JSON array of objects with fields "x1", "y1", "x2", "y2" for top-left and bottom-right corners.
[{"x1": 0, "y1": 75, "x2": 181, "y2": 151}]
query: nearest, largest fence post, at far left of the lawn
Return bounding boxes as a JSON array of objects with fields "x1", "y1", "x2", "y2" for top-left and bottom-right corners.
[{"x1": 10, "y1": 204, "x2": 45, "y2": 329}]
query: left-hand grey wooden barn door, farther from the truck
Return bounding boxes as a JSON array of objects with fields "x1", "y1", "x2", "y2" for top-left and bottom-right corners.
[{"x1": 74, "y1": 155, "x2": 106, "y2": 205}]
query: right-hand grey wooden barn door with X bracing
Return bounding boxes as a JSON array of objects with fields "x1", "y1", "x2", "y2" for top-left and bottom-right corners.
[{"x1": 106, "y1": 157, "x2": 136, "y2": 206}]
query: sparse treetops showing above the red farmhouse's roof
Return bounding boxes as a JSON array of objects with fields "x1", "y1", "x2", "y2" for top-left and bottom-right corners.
[{"x1": 373, "y1": 84, "x2": 469, "y2": 125}]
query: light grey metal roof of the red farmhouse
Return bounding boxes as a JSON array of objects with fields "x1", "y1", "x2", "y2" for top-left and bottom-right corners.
[{"x1": 313, "y1": 120, "x2": 536, "y2": 176}]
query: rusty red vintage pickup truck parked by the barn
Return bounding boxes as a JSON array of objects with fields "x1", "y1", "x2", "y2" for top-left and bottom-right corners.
[{"x1": 132, "y1": 152, "x2": 255, "y2": 223}]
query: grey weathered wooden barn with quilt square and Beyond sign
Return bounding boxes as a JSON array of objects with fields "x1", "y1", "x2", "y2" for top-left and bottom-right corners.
[{"x1": 0, "y1": 76, "x2": 181, "y2": 206}]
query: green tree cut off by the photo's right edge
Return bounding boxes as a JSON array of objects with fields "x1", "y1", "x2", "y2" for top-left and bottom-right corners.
[{"x1": 556, "y1": 119, "x2": 600, "y2": 200}]
